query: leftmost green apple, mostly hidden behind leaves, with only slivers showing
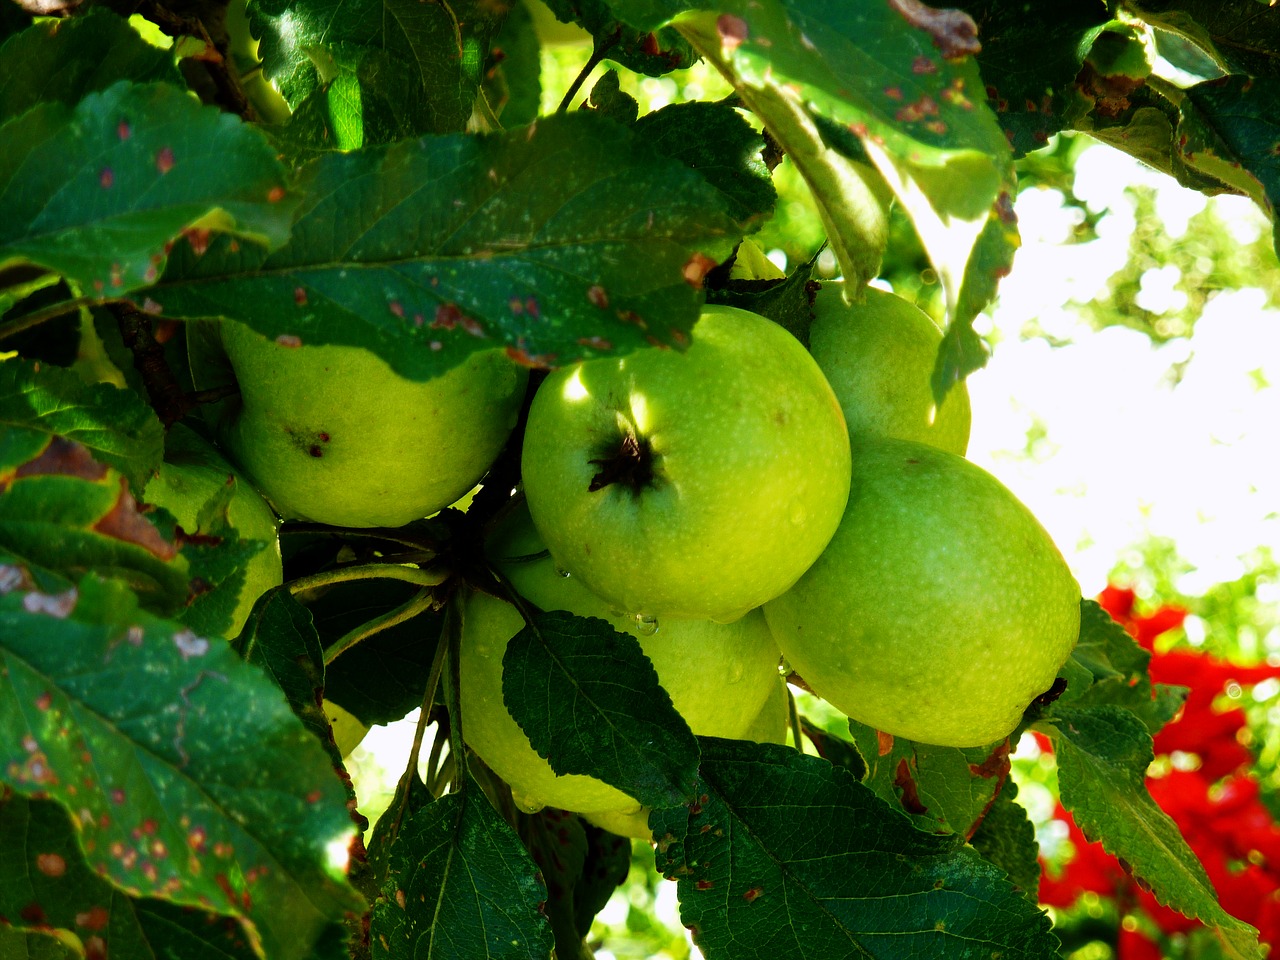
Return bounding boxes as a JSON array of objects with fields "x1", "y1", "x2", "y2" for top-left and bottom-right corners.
[{"x1": 142, "y1": 424, "x2": 283, "y2": 637}]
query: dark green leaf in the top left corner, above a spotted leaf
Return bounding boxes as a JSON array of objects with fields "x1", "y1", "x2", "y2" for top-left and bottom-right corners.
[{"x1": 0, "y1": 6, "x2": 182, "y2": 120}]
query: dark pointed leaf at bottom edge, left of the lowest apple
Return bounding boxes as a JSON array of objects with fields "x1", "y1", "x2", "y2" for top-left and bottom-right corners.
[{"x1": 370, "y1": 781, "x2": 552, "y2": 960}]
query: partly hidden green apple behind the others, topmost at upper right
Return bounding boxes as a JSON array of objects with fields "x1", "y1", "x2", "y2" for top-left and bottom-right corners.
[{"x1": 809, "y1": 283, "x2": 970, "y2": 456}]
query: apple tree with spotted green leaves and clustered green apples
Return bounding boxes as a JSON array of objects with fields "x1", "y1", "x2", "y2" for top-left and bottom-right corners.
[{"x1": 0, "y1": 0, "x2": 1280, "y2": 960}]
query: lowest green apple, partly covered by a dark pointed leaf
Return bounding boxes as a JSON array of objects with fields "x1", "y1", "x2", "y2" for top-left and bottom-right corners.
[{"x1": 460, "y1": 504, "x2": 780, "y2": 814}]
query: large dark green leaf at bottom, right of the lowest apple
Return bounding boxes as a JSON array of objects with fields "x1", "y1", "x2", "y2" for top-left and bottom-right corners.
[{"x1": 649, "y1": 739, "x2": 1057, "y2": 960}]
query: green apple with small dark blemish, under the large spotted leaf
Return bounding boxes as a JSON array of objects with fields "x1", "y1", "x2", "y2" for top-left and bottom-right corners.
[{"x1": 188, "y1": 321, "x2": 527, "y2": 535}]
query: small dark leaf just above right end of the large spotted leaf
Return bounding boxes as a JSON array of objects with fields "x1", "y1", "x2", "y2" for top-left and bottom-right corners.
[{"x1": 635, "y1": 100, "x2": 778, "y2": 233}]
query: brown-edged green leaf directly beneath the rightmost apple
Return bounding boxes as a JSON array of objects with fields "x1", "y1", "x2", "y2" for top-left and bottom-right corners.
[{"x1": 849, "y1": 719, "x2": 1009, "y2": 838}]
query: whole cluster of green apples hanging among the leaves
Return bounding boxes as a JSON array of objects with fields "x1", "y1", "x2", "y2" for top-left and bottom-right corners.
[{"x1": 165, "y1": 283, "x2": 1079, "y2": 836}]
